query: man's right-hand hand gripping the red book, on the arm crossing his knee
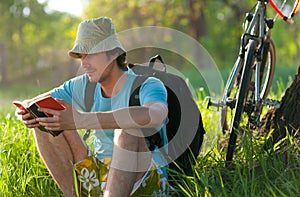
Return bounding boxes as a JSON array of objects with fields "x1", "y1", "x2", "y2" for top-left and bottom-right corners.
[{"x1": 36, "y1": 100, "x2": 80, "y2": 131}]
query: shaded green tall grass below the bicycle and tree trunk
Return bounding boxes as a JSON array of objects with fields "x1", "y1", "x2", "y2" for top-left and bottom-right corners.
[{"x1": 172, "y1": 129, "x2": 300, "y2": 197}]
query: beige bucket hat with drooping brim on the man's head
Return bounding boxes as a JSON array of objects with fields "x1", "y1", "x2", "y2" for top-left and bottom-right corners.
[{"x1": 69, "y1": 17, "x2": 125, "y2": 58}]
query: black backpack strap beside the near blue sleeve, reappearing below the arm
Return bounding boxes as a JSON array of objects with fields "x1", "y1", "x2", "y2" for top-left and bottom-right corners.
[{"x1": 129, "y1": 75, "x2": 163, "y2": 151}]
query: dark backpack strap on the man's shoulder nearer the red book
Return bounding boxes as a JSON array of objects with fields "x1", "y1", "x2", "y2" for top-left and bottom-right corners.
[{"x1": 83, "y1": 79, "x2": 97, "y2": 141}]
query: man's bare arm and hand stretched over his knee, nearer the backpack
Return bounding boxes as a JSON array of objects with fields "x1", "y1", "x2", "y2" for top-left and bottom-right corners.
[{"x1": 36, "y1": 101, "x2": 168, "y2": 130}]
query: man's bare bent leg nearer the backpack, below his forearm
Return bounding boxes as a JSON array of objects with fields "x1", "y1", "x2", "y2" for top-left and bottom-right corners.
[{"x1": 104, "y1": 130, "x2": 152, "y2": 197}]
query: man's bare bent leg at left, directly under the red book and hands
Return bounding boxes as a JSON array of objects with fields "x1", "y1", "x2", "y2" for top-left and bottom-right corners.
[{"x1": 34, "y1": 128, "x2": 88, "y2": 197}]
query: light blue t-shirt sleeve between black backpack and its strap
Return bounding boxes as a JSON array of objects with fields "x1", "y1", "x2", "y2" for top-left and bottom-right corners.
[{"x1": 139, "y1": 77, "x2": 168, "y2": 106}]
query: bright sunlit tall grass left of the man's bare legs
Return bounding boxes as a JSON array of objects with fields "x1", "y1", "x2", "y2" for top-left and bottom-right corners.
[{"x1": 0, "y1": 113, "x2": 62, "y2": 197}]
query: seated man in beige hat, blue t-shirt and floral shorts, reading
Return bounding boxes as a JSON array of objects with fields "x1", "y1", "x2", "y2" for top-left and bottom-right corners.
[{"x1": 18, "y1": 17, "x2": 168, "y2": 197}]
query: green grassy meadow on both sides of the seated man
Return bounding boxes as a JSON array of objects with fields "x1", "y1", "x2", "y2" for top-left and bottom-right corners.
[{"x1": 0, "y1": 66, "x2": 300, "y2": 197}]
